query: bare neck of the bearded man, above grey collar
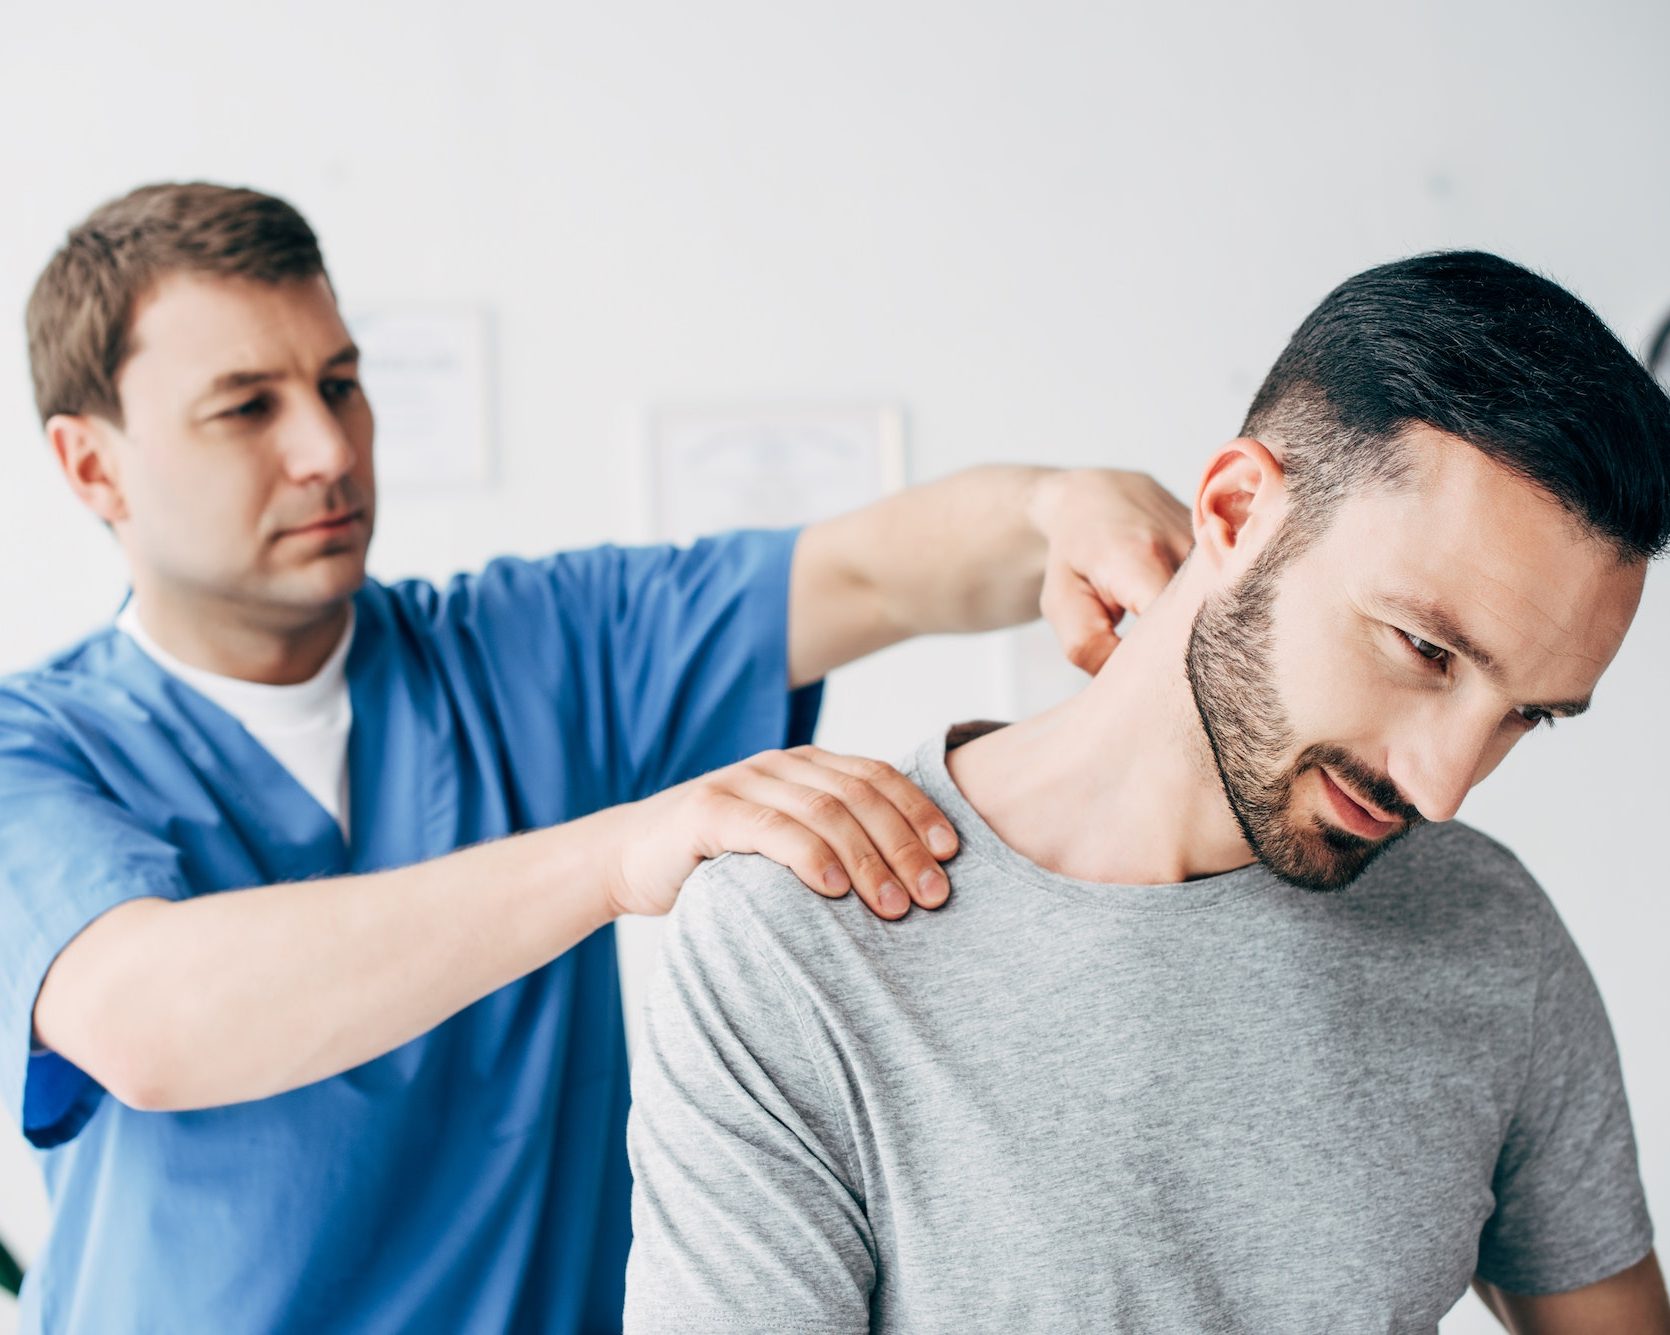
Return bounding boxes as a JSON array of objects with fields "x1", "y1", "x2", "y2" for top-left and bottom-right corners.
[{"x1": 947, "y1": 598, "x2": 1253, "y2": 886}]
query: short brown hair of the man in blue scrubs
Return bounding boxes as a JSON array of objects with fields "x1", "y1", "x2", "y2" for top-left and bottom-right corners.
[{"x1": 25, "y1": 182, "x2": 324, "y2": 424}]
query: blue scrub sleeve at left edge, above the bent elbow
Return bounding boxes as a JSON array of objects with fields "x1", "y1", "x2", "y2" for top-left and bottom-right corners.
[{"x1": 0, "y1": 692, "x2": 187, "y2": 1150}]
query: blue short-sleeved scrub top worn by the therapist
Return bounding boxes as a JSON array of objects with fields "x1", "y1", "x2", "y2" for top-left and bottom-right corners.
[{"x1": 0, "y1": 533, "x2": 818, "y2": 1335}]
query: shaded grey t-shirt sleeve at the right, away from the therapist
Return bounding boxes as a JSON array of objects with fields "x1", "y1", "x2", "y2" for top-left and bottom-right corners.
[{"x1": 1478, "y1": 916, "x2": 1653, "y2": 1295}]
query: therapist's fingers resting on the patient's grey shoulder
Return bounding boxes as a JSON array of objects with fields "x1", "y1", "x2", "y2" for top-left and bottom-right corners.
[{"x1": 730, "y1": 754, "x2": 950, "y2": 919}]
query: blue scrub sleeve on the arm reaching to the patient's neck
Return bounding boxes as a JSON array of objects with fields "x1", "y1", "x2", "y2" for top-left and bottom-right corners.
[{"x1": 469, "y1": 531, "x2": 822, "y2": 802}]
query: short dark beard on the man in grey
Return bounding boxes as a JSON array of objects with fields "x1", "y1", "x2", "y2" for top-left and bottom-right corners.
[{"x1": 1184, "y1": 516, "x2": 1421, "y2": 891}]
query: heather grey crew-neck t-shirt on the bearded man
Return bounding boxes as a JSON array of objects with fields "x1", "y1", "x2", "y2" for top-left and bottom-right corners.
[{"x1": 626, "y1": 742, "x2": 1652, "y2": 1335}]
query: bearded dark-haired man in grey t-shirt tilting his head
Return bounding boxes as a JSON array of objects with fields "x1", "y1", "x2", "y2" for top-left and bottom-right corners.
[{"x1": 626, "y1": 254, "x2": 1670, "y2": 1335}]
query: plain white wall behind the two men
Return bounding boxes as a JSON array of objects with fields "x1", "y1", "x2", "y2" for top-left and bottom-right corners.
[{"x1": 0, "y1": 0, "x2": 1670, "y2": 1332}]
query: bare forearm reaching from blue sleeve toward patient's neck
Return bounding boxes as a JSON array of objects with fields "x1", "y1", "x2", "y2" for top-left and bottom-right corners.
[{"x1": 790, "y1": 464, "x2": 1054, "y2": 683}]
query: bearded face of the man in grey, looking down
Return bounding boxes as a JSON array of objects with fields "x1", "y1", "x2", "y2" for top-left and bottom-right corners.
[{"x1": 1186, "y1": 428, "x2": 1645, "y2": 891}]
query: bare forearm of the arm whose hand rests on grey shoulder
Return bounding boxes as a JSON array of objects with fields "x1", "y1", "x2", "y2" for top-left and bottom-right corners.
[{"x1": 35, "y1": 812, "x2": 615, "y2": 1109}]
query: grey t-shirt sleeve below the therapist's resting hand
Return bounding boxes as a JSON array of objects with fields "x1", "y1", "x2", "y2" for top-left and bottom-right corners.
[{"x1": 626, "y1": 859, "x2": 875, "y2": 1335}]
